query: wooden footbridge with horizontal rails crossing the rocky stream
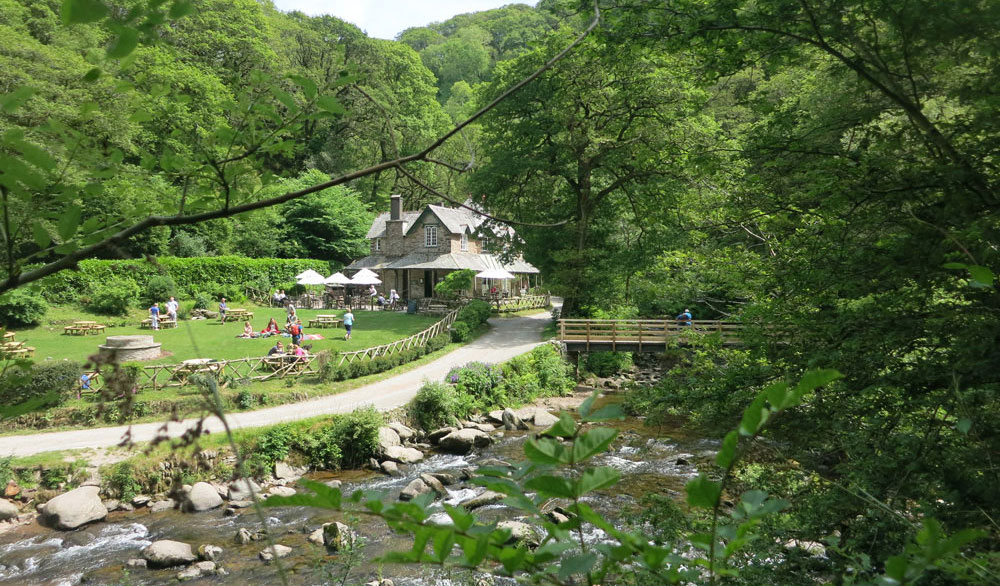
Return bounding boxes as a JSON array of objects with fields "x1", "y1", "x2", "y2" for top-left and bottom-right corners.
[{"x1": 558, "y1": 319, "x2": 743, "y2": 352}]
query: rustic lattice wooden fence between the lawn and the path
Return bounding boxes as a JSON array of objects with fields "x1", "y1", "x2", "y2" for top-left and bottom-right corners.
[{"x1": 138, "y1": 309, "x2": 459, "y2": 390}]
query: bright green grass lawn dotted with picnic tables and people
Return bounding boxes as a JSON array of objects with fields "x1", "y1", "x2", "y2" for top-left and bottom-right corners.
[{"x1": 16, "y1": 303, "x2": 441, "y2": 364}]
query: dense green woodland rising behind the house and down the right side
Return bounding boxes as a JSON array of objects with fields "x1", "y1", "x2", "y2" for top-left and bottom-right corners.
[{"x1": 0, "y1": 0, "x2": 1000, "y2": 584}]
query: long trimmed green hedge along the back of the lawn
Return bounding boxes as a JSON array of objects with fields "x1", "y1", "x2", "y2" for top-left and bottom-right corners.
[{"x1": 41, "y1": 256, "x2": 330, "y2": 303}]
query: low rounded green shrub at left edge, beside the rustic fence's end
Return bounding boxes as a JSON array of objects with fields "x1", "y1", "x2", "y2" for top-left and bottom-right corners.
[{"x1": 0, "y1": 361, "x2": 83, "y2": 408}]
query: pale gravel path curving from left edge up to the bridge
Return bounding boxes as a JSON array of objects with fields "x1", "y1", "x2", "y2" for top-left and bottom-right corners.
[{"x1": 0, "y1": 313, "x2": 551, "y2": 457}]
